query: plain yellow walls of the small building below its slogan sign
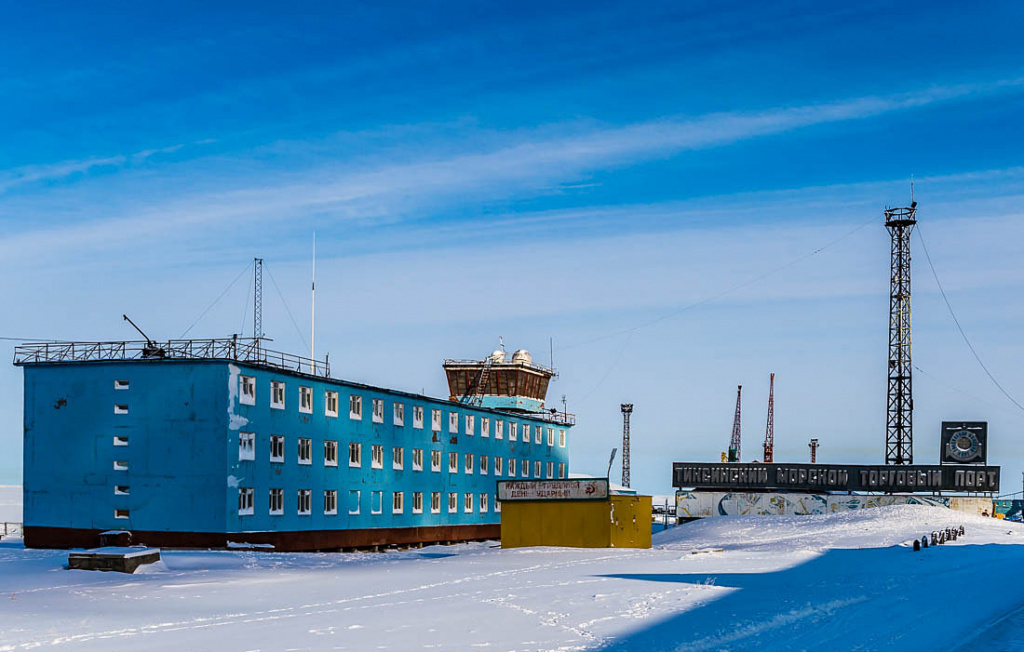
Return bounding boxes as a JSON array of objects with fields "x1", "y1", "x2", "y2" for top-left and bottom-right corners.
[{"x1": 502, "y1": 495, "x2": 651, "y2": 548}]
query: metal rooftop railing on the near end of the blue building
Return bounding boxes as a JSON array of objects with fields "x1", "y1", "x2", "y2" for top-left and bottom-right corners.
[{"x1": 14, "y1": 338, "x2": 331, "y2": 378}]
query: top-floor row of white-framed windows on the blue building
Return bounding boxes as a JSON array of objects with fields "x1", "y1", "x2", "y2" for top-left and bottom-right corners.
[{"x1": 240, "y1": 376, "x2": 565, "y2": 448}]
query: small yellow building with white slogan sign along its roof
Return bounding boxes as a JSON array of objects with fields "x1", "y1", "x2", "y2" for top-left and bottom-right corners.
[{"x1": 498, "y1": 478, "x2": 651, "y2": 548}]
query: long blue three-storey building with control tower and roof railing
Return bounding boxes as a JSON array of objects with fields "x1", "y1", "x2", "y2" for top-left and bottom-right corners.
[{"x1": 15, "y1": 339, "x2": 574, "y2": 551}]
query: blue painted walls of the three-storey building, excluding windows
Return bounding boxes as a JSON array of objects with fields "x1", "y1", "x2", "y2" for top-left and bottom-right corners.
[{"x1": 25, "y1": 360, "x2": 568, "y2": 532}]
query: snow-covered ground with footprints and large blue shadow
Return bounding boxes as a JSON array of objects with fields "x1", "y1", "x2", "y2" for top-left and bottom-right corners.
[{"x1": 0, "y1": 506, "x2": 1024, "y2": 652}]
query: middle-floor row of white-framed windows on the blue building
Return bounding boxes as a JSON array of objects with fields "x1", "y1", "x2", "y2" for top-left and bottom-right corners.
[{"x1": 236, "y1": 432, "x2": 565, "y2": 478}]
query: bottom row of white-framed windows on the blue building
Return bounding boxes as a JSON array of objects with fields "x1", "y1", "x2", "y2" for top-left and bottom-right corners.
[{"x1": 236, "y1": 487, "x2": 502, "y2": 518}]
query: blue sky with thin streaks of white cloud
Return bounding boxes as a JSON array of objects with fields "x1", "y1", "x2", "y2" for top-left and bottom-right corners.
[{"x1": 0, "y1": 2, "x2": 1024, "y2": 492}]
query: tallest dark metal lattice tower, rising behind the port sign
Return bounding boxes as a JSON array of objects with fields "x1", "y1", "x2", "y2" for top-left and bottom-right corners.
[{"x1": 886, "y1": 202, "x2": 918, "y2": 465}]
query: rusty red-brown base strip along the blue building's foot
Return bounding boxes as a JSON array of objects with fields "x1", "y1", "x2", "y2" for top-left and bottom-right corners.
[{"x1": 25, "y1": 523, "x2": 502, "y2": 552}]
